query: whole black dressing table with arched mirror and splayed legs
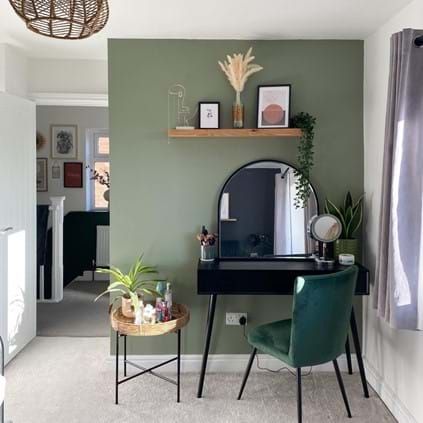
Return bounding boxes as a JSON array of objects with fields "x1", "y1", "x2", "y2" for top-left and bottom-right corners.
[{"x1": 197, "y1": 160, "x2": 369, "y2": 398}]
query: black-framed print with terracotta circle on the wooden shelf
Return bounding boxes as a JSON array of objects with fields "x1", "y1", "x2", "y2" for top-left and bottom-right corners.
[{"x1": 257, "y1": 85, "x2": 291, "y2": 128}]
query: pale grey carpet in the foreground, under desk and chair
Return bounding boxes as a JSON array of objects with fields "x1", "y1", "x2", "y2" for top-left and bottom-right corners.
[{"x1": 6, "y1": 338, "x2": 395, "y2": 423}]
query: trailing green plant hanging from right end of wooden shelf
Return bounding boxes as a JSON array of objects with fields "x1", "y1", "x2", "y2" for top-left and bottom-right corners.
[{"x1": 292, "y1": 112, "x2": 316, "y2": 208}]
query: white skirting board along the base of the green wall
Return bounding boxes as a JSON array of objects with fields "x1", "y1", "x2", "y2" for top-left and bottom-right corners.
[{"x1": 109, "y1": 354, "x2": 358, "y2": 373}]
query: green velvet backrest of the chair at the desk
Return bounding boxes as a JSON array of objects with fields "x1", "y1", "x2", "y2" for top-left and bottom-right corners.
[{"x1": 289, "y1": 266, "x2": 358, "y2": 367}]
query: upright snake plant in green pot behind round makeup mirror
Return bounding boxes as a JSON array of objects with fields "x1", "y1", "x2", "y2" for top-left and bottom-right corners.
[{"x1": 325, "y1": 191, "x2": 364, "y2": 259}]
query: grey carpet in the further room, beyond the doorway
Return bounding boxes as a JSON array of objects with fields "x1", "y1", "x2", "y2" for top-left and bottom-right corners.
[{"x1": 37, "y1": 281, "x2": 110, "y2": 337}]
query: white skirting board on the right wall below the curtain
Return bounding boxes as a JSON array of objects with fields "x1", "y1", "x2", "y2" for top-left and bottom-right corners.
[{"x1": 364, "y1": 358, "x2": 418, "y2": 423}]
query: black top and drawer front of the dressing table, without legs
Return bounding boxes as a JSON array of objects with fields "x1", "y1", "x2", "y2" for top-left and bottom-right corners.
[{"x1": 197, "y1": 259, "x2": 369, "y2": 295}]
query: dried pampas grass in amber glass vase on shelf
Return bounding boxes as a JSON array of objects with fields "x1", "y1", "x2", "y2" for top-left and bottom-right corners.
[{"x1": 218, "y1": 47, "x2": 263, "y2": 128}]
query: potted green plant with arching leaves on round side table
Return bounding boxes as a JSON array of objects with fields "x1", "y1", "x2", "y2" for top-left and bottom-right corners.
[{"x1": 94, "y1": 256, "x2": 165, "y2": 317}]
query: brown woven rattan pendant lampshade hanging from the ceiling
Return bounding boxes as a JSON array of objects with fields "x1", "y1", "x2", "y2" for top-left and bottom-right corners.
[{"x1": 9, "y1": 0, "x2": 109, "y2": 40}]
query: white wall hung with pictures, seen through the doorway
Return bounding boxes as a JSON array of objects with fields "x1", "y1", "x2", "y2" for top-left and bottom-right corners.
[{"x1": 37, "y1": 106, "x2": 109, "y2": 214}]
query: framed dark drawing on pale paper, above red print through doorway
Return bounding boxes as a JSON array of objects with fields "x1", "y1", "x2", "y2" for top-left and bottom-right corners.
[{"x1": 51, "y1": 125, "x2": 78, "y2": 159}]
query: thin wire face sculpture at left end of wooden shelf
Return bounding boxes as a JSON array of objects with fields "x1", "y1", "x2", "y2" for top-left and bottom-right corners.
[{"x1": 167, "y1": 84, "x2": 198, "y2": 129}]
